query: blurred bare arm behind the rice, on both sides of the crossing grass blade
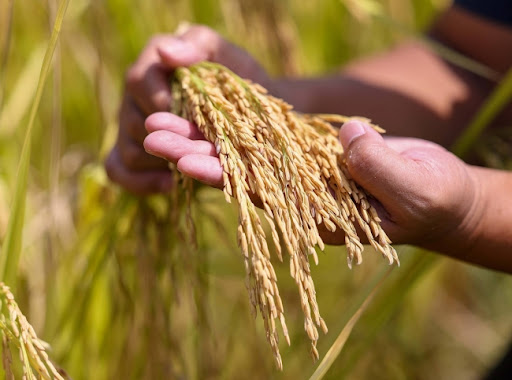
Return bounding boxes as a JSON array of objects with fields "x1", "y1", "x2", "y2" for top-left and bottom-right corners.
[{"x1": 275, "y1": 7, "x2": 512, "y2": 147}]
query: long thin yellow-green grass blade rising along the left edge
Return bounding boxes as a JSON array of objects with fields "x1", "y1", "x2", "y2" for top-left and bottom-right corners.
[{"x1": 0, "y1": 0, "x2": 69, "y2": 290}]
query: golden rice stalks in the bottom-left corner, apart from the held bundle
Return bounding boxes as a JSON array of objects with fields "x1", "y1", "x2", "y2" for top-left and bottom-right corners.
[{"x1": 0, "y1": 282, "x2": 68, "y2": 380}]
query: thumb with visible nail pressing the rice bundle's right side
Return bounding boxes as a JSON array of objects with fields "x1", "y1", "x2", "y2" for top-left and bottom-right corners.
[{"x1": 339, "y1": 120, "x2": 417, "y2": 203}]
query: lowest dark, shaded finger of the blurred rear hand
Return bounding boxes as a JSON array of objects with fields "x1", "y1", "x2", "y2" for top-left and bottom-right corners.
[{"x1": 105, "y1": 148, "x2": 173, "y2": 195}]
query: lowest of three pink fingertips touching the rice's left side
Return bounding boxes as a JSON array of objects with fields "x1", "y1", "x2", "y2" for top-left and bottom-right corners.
[{"x1": 177, "y1": 154, "x2": 224, "y2": 189}]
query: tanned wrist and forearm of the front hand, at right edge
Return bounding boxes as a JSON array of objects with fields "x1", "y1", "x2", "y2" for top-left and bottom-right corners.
[{"x1": 427, "y1": 166, "x2": 512, "y2": 273}]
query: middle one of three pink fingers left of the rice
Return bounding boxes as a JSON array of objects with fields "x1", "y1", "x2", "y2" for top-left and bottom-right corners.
[{"x1": 144, "y1": 130, "x2": 216, "y2": 163}]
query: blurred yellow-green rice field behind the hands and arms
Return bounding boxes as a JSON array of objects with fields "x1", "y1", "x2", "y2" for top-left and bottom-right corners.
[{"x1": 0, "y1": 0, "x2": 512, "y2": 379}]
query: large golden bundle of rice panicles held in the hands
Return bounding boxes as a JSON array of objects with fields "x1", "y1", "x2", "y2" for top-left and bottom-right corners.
[{"x1": 172, "y1": 62, "x2": 399, "y2": 368}]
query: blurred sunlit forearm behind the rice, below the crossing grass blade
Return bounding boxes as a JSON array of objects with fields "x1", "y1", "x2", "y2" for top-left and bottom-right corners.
[{"x1": 276, "y1": 43, "x2": 490, "y2": 146}]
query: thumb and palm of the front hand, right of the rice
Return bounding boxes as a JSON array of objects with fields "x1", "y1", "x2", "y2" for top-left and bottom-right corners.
[{"x1": 340, "y1": 121, "x2": 479, "y2": 251}]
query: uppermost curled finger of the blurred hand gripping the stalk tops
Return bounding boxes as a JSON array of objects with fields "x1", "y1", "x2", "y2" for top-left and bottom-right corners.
[{"x1": 125, "y1": 35, "x2": 177, "y2": 115}]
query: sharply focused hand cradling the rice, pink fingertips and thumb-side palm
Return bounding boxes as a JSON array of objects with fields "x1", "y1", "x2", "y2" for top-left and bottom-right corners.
[{"x1": 144, "y1": 113, "x2": 477, "y2": 251}]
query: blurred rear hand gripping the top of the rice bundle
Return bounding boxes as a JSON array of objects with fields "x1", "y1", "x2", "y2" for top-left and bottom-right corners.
[{"x1": 105, "y1": 26, "x2": 270, "y2": 195}]
